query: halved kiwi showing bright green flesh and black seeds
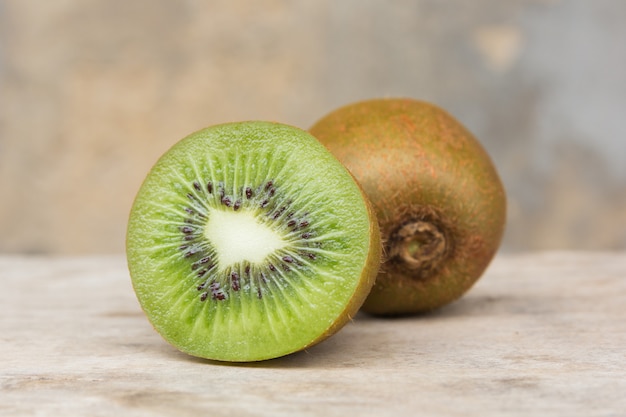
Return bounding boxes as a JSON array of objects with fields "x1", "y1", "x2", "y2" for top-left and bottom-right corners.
[{"x1": 126, "y1": 121, "x2": 381, "y2": 362}]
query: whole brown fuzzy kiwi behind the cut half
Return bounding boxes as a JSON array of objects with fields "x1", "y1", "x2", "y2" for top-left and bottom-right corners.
[{"x1": 309, "y1": 98, "x2": 506, "y2": 315}]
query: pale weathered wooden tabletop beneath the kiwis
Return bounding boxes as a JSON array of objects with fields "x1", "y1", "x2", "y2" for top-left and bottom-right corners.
[{"x1": 0, "y1": 252, "x2": 626, "y2": 417}]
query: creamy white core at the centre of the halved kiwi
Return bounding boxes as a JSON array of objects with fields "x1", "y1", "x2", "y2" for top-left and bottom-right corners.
[{"x1": 204, "y1": 209, "x2": 287, "y2": 270}]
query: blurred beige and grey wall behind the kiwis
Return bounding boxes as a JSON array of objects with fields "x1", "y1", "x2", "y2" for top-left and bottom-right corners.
[{"x1": 0, "y1": 0, "x2": 626, "y2": 254}]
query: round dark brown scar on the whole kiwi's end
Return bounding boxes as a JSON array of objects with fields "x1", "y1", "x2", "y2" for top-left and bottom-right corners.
[{"x1": 389, "y1": 220, "x2": 447, "y2": 271}]
